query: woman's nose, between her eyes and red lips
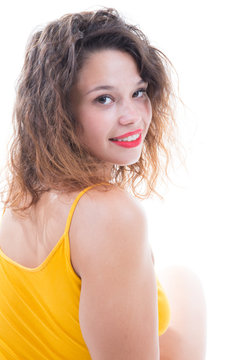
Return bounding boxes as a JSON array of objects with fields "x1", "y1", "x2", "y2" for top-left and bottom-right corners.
[{"x1": 118, "y1": 100, "x2": 141, "y2": 125}]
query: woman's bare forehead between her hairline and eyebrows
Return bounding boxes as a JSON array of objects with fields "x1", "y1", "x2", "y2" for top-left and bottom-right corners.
[{"x1": 77, "y1": 49, "x2": 141, "y2": 87}]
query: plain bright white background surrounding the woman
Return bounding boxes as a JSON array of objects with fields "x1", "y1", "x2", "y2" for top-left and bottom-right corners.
[{"x1": 0, "y1": 0, "x2": 240, "y2": 360}]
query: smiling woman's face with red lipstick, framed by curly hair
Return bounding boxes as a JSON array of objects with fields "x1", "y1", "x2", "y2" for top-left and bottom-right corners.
[{"x1": 71, "y1": 50, "x2": 152, "y2": 167}]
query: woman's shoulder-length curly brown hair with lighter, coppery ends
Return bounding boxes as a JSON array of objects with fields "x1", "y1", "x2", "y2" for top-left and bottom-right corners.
[{"x1": 2, "y1": 8, "x2": 180, "y2": 211}]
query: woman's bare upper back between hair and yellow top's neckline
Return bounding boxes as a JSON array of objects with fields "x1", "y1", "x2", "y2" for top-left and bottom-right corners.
[{"x1": 0, "y1": 187, "x2": 95, "y2": 277}]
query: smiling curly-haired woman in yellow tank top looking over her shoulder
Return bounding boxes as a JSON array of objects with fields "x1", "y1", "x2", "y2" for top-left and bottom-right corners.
[{"x1": 0, "y1": 9, "x2": 206, "y2": 360}]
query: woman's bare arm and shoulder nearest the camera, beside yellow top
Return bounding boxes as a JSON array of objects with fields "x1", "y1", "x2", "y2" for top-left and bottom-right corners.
[{"x1": 79, "y1": 191, "x2": 159, "y2": 360}]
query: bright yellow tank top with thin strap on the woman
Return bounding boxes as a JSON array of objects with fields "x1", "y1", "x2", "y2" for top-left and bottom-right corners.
[{"x1": 0, "y1": 185, "x2": 170, "y2": 360}]
